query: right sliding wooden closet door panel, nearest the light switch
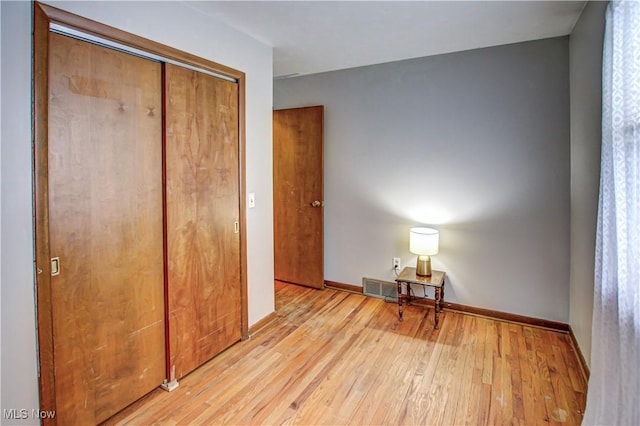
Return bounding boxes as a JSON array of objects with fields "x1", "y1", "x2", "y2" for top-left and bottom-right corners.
[{"x1": 165, "y1": 64, "x2": 241, "y2": 378}]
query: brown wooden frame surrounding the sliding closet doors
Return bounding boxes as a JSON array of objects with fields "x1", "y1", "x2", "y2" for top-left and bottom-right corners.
[{"x1": 32, "y1": 2, "x2": 249, "y2": 424}]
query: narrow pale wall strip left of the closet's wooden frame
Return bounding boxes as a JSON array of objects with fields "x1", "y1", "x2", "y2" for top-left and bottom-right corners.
[{"x1": 0, "y1": 1, "x2": 38, "y2": 424}]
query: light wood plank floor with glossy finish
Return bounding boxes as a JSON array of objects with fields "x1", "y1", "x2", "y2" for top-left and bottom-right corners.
[{"x1": 108, "y1": 283, "x2": 586, "y2": 425}]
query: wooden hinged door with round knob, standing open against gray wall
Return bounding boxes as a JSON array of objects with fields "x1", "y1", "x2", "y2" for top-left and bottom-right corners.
[{"x1": 273, "y1": 106, "x2": 324, "y2": 288}]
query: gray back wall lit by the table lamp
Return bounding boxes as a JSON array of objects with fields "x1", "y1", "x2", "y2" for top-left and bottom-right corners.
[{"x1": 274, "y1": 37, "x2": 570, "y2": 322}]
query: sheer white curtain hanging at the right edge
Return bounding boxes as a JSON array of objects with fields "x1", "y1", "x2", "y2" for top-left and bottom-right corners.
[{"x1": 583, "y1": 0, "x2": 640, "y2": 425}]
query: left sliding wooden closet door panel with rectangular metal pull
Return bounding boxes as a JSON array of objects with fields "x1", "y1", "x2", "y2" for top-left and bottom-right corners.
[{"x1": 48, "y1": 33, "x2": 165, "y2": 425}]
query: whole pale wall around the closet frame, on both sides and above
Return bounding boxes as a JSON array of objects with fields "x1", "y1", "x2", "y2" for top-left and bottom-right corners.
[{"x1": 1, "y1": 1, "x2": 274, "y2": 423}]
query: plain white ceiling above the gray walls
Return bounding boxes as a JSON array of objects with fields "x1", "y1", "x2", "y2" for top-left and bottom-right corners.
[{"x1": 186, "y1": 1, "x2": 586, "y2": 78}]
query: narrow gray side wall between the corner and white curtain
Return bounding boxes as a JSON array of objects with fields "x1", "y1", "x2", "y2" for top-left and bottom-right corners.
[{"x1": 569, "y1": 2, "x2": 607, "y2": 363}]
